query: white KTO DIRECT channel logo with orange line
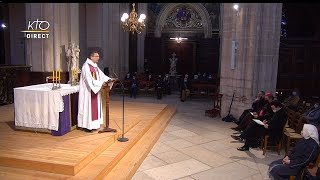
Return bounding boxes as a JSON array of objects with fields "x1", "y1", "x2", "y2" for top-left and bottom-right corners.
[{"x1": 21, "y1": 19, "x2": 50, "y2": 39}]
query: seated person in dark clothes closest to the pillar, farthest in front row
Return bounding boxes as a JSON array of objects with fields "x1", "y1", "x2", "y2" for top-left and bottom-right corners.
[{"x1": 231, "y1": 91, "x2": 266, "y2": 126}]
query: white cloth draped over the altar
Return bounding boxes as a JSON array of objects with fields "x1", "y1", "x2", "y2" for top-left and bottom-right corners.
[{"x1": 14, "y1": 83, "x2": 79, "y2": 131}]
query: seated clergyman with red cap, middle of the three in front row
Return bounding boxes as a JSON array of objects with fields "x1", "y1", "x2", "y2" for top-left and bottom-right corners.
[{"x1": 233, "y1": 92, "x2": 274, "y2": 131}]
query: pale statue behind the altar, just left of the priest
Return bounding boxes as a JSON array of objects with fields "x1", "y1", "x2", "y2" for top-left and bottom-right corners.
[{"x1": 66, "y1": 43, "x2": 80, "y2": 82}]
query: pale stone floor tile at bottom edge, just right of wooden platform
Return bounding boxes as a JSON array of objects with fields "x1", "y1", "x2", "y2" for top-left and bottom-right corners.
[{"x1": 144, "y1": 159, "x2": 210, "y2": 180}]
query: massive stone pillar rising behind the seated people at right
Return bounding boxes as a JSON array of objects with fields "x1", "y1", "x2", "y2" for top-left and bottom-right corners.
[{"x1": 220, "y1": 3, "x2": 282, "y2": 118}]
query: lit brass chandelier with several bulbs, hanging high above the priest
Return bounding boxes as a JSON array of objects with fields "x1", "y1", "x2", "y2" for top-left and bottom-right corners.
[{"x1": 121, "y1": 3, "x2": 146, "y2": 34}]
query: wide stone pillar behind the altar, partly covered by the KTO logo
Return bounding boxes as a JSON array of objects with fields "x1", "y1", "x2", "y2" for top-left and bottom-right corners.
[{"x1": 26, "y1": 3, "x2": 79, "y2": 72}]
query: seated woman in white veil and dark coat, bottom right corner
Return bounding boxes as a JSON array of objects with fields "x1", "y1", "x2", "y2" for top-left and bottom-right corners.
[{"x1": 269, "y1": 124, "x2": 319, "y2": 180}]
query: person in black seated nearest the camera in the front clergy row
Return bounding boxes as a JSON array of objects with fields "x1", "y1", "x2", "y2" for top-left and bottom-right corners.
[{"x1": 231, "y1": 100, "x2": 287, "y2": 151}]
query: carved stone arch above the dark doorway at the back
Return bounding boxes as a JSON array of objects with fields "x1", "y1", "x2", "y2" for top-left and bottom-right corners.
[{"x1": 155, "y1": 3, "x2": 212, "y2": 38}]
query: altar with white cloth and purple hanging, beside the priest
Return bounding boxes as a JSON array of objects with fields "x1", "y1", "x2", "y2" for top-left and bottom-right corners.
[{"x1": 14, "y1": 83, "x2": 79, "y2": 136}]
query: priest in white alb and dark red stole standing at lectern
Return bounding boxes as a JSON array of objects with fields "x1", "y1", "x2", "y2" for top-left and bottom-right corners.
[{"x1": 78, "y1": 51, "x2": 116, "y2": 132}]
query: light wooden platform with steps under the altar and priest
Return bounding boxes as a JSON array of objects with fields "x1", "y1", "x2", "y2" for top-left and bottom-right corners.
[{"x1": 0, "y1": 101, "x2": 176, "y2": 179}]
